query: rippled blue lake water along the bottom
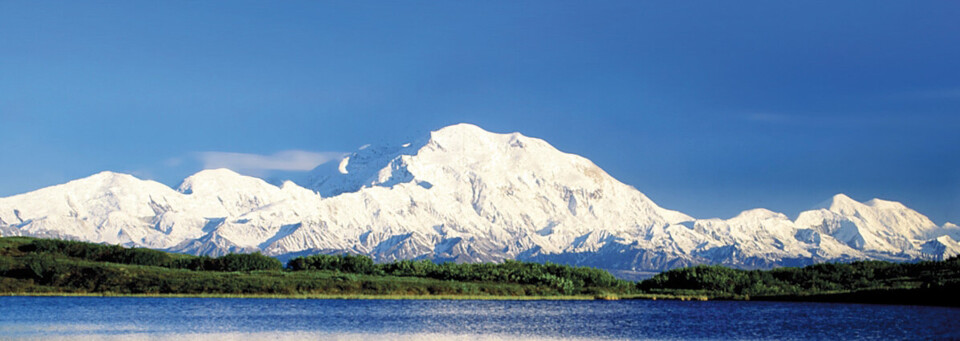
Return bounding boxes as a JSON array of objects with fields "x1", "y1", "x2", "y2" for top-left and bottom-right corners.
[{"x1": 0, "y1": 297, "x2": 960, "y2": 341}]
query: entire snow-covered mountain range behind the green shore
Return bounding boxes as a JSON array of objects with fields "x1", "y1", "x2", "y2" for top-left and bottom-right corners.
[{"x1": 0, "y1": 124, "x2": 960, "y2": 271}]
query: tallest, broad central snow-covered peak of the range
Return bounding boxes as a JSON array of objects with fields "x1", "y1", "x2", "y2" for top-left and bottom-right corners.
[{"x1": 266, "y1": 124, "x2": 692, "y2": 261}]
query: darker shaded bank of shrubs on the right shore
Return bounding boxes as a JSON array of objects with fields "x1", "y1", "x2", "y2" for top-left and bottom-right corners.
[{"x1": 637, "y1": 256, "x2": 960, "y2": 306}]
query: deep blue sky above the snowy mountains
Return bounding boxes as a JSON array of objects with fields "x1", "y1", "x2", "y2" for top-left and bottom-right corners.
[{"x1": 0, "y1": 1, "x2": 960, "y2": 224}]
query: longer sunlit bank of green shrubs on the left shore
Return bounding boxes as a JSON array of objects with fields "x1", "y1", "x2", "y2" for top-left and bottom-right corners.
[{"x1": 0, "y1": 237, "x2": 635, "y2": 298}]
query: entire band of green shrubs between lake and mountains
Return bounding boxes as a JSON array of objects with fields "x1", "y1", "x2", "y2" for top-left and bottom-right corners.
[{"x1": 0, "y1": 237, "x2": 960, "y2": 306}]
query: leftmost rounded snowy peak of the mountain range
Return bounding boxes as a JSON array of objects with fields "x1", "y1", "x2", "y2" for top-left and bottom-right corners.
[{"x1": 0, "y1": 172, "x2": 199, "y2": 248}]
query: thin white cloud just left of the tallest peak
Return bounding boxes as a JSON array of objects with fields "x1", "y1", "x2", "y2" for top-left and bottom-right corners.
[{"x1": 196, "y1": 150, "x2": 343, "y2": 172}]
